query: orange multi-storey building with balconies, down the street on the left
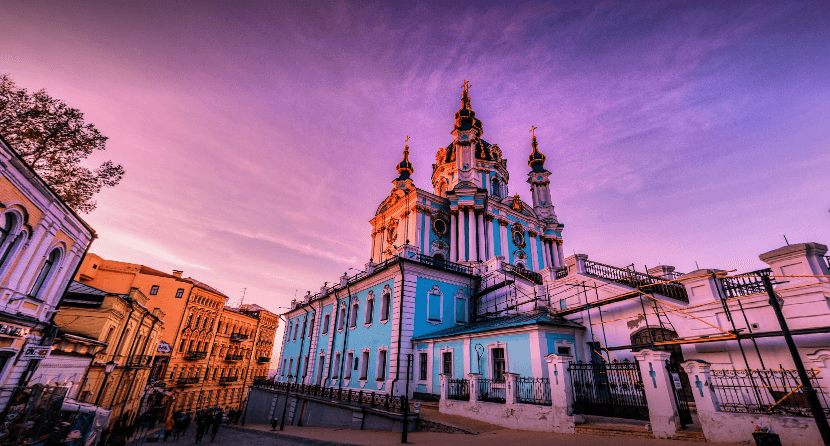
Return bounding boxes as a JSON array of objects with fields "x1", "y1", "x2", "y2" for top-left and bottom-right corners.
[{"x1": 77, "y1": 254, "x2": 278, "y2": 411}]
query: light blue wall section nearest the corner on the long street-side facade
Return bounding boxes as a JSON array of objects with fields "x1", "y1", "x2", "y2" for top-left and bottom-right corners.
[{"x1": 332, "y1": 279, "x2": 397, "y2": 391}]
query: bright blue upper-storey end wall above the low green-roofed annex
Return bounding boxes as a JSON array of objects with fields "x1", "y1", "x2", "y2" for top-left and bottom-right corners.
[{"x1": 412, "y1": 277, "x2": 470, "y2": 337}]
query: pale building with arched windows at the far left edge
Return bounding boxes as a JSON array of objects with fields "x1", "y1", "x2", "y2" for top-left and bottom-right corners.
[{"x1": 0, "y1": 134, "x2": 95, "y2": 407}]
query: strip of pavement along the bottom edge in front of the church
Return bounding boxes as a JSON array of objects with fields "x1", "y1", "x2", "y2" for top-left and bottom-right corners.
[{"x1": 239, "y1": 424, "x2": 746, "y2": 446}]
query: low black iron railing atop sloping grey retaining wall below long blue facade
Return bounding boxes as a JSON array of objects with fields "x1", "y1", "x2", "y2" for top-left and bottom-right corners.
[{"x1": 254, "y1": 379, "x2": 408, "y2": 413}]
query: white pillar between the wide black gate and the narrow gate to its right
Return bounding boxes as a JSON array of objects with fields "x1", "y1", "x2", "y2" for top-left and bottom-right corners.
[{"x1": 634, "y1": 349, "x2": 680, "y2": 439}]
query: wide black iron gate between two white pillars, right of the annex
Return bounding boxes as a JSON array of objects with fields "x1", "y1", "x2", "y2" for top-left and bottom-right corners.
[{"x1": 568, "y1": 359, "x2": 648, "y2": 420}]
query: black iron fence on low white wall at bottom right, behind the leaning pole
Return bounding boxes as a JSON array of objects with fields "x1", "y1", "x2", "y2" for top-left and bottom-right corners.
[{"x1": 712, "y1": 369, "x2": 830, "y2": 417}]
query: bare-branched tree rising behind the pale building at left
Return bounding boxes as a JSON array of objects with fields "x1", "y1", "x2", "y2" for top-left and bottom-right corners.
[{"x1": 0, "y1": 74, "x2": 124, "y2": 213}]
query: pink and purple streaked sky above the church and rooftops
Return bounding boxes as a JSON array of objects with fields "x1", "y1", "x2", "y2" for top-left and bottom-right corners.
[{"x1": 0, "y1": 1, "x2": 830, "y2": 356}]
